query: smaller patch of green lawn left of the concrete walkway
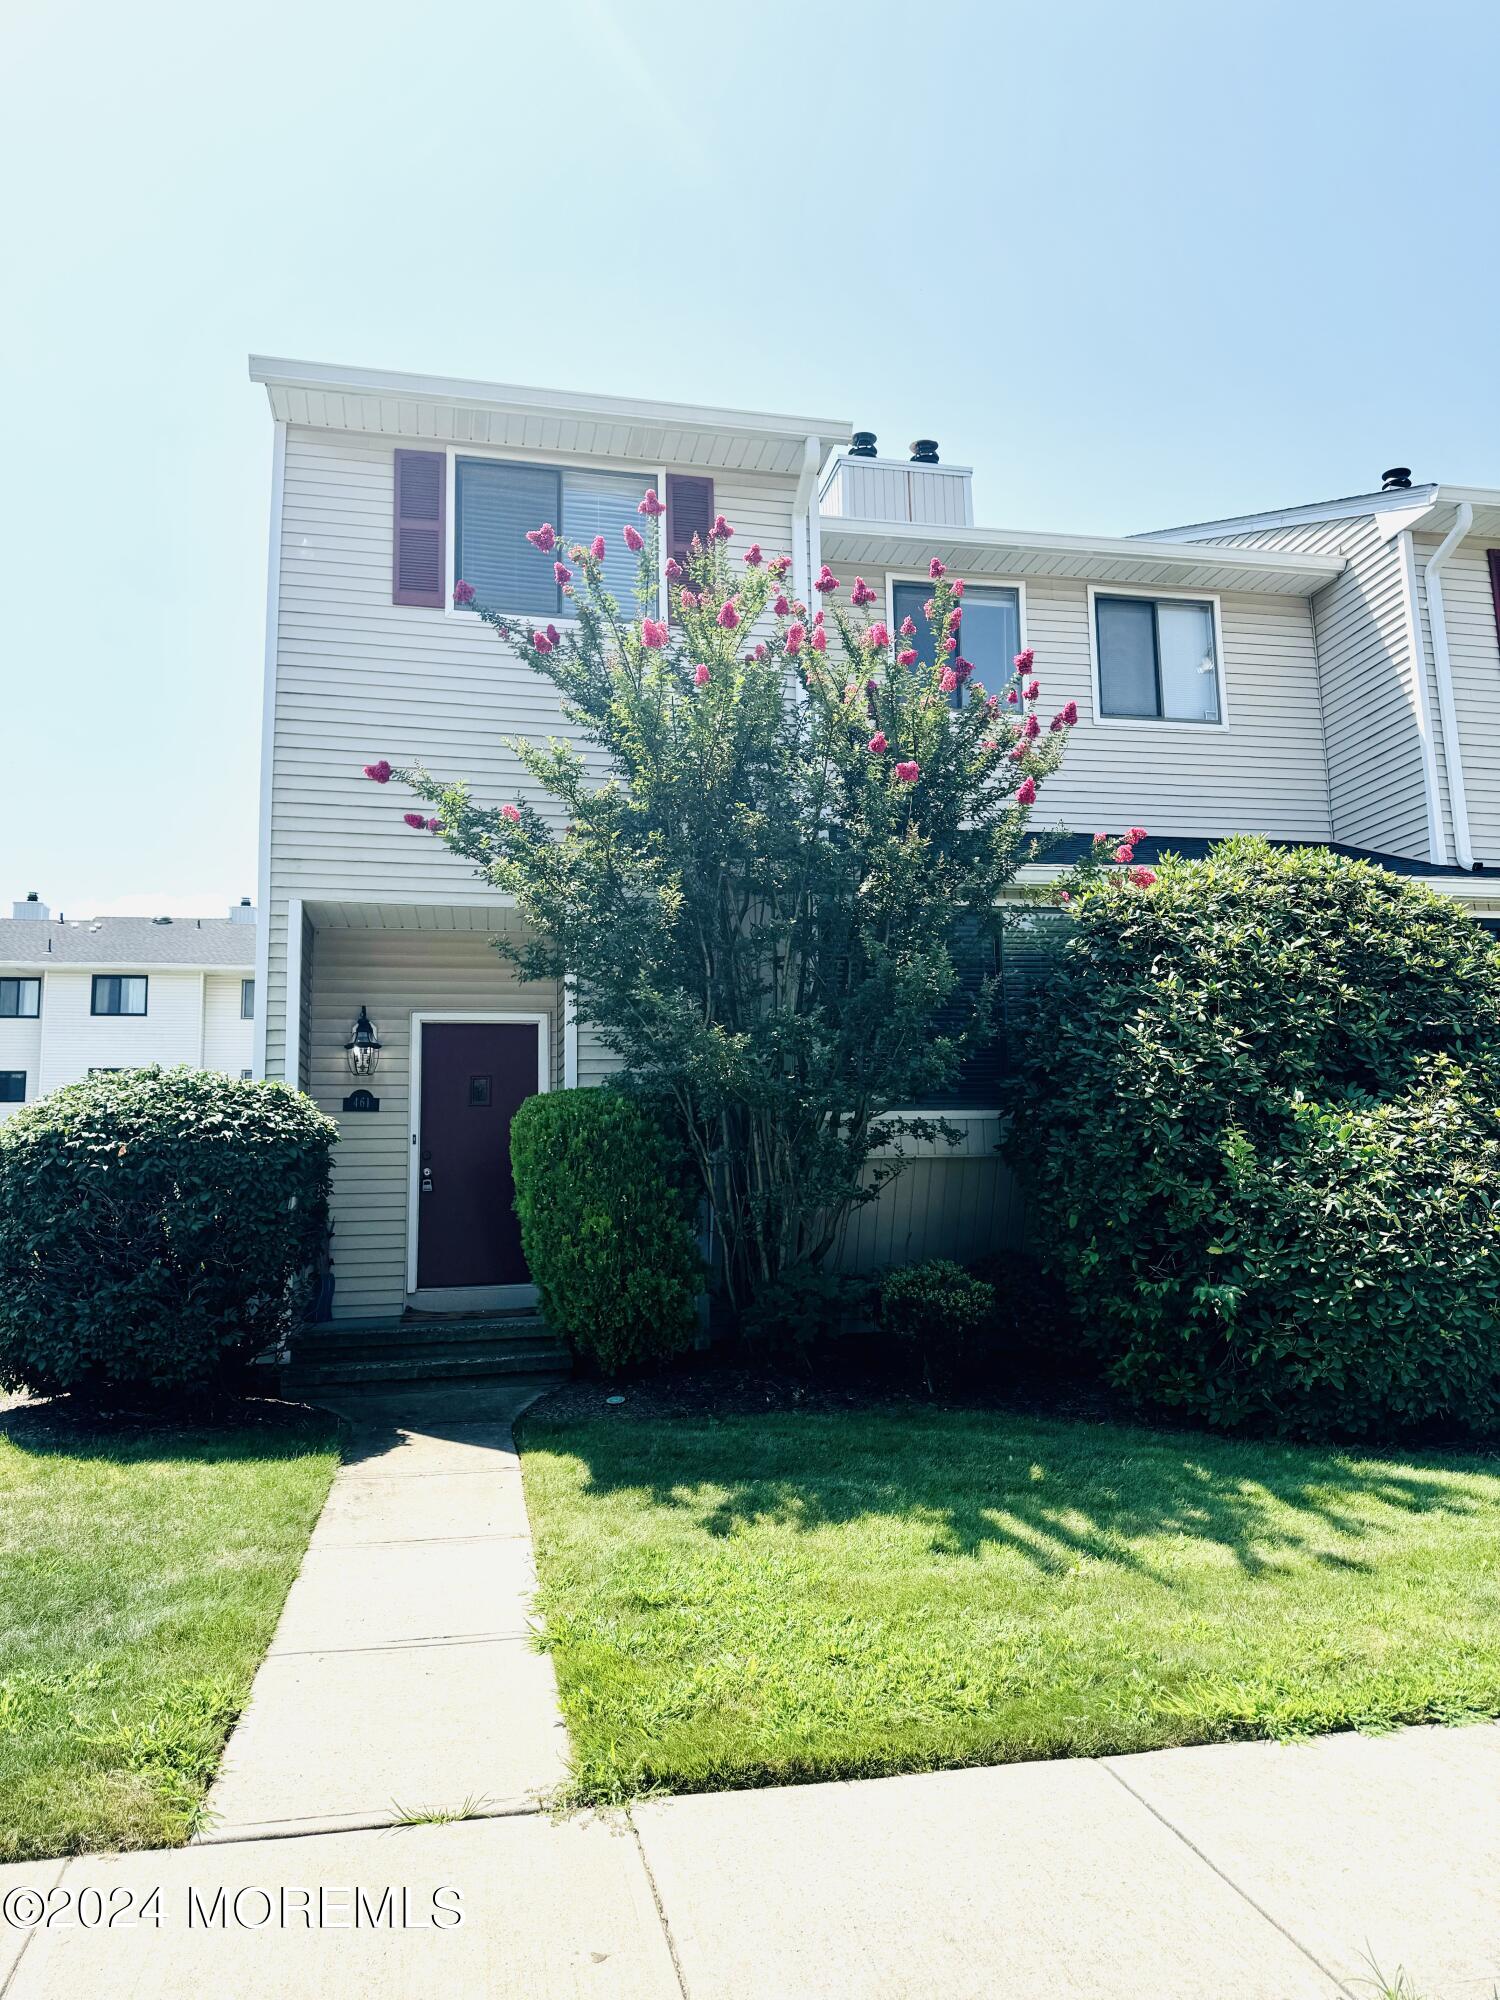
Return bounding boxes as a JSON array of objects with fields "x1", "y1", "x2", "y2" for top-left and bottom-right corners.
[{"x1": 0, "y1": 1406, "x2": 338, "y2": 1862}]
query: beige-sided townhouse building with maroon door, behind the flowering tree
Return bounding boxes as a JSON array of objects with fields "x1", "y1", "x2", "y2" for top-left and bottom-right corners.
[{"x1": 252, "y1": 360, "x2": 1500, "y2": 1318}]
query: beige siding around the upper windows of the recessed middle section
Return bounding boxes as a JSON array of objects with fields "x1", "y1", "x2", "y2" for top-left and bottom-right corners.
[{"x1": 842, "y1": 566, "x2": 1330, "y2": 840}]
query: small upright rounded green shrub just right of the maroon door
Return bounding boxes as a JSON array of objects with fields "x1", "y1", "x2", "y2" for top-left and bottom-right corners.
[{"x1": 510, "y1": 1088, "x2": 706, "y2": 1374}]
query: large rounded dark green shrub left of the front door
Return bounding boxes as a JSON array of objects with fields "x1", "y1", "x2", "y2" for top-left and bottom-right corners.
[{"x1": 0, "y1": 1068, "x2": 338, "y2": 1396}]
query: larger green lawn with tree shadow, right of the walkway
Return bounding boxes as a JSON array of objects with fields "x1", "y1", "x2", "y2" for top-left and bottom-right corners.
[{"x1": 522, "y1": 1398, "x2": 1500, "y2": 1800}]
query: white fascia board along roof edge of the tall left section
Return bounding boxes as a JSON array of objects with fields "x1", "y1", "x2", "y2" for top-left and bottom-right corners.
[{"x1": 250, "y1": 354, "x2": 850, "y2": 448}]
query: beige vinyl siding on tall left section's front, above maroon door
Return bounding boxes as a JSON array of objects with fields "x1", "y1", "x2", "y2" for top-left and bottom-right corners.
[{"x1": 262, "y1": 426, "x2": 812, "y2": 1076}]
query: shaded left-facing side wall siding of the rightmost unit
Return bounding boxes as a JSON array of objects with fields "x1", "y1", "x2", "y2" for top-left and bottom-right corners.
[{"x1": 1220, "y1": 514, "x2": 1446, "y2": 860}]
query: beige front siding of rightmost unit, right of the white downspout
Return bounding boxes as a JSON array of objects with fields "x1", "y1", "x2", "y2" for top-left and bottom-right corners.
[{"x1": 1412, "y1": 536, "x2": 1500, "y2": 868}]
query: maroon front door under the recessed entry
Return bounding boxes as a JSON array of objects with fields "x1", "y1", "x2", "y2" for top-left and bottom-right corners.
[{"x1": 416, "y1": 1020, "x2": 540, "y2": 1288}]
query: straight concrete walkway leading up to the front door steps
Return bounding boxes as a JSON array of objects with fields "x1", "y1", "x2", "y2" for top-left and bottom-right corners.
[{"x1": 198, "y1": 1378, "x2": 568, "y2": 1844}]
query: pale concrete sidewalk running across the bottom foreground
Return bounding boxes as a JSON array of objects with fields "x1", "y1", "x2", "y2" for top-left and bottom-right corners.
[{"x1": 0, "y1": 1724, "x2": 1500, "y2": 2000}]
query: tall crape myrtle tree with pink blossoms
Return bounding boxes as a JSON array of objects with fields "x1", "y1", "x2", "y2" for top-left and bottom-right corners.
[{"x1": 366, "y1": 492, "x2": 1150, "y2": 1312}]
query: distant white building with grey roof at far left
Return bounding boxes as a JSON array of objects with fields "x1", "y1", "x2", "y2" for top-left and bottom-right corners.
[{"x1": 0, "y1": 896, "x2": 256, "y2": 1118}]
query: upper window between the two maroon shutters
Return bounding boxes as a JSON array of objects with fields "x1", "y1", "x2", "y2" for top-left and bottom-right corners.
[{"x1": 454, "y1": 458, "x2": 652, "y2": 618}]
